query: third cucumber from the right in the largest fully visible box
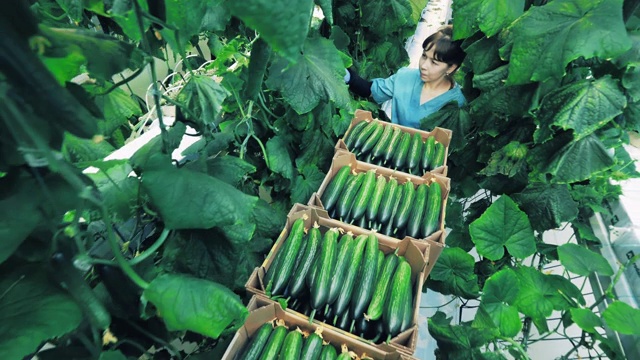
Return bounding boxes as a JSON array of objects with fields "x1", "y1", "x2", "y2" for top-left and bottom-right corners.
[{"x1": 351, "y1": 233, "x2": 379, "y2": 328}]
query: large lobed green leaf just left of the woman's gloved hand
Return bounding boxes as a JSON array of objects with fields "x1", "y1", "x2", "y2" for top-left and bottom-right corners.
[{"x1": 267, "y1": 38, "x2": 350, "y2": 114}]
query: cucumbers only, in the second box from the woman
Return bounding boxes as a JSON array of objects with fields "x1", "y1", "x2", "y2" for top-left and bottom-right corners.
[{"x1": 320, "y1": 165, "x2": 442, "y2": 239}]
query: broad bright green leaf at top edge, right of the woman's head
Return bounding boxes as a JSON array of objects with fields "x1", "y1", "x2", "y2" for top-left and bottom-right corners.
[{"x1": 502, "y1": 0, "x2": 631, "y2": 84}]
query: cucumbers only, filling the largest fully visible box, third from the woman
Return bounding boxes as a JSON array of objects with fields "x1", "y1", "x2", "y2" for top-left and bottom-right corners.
[{"x1": 264, "y1": 218, "x2": 414, "y2": 343}]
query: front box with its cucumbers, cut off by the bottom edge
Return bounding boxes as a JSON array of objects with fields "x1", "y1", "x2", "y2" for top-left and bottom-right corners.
[{"x1": 222, "y1": 296, "x2": 415, "y2": 360}]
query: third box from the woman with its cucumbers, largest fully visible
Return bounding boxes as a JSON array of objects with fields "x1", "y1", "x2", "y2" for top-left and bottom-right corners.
[{"x1": 246, "y1": 205, "x2": 429, "y2": 354}]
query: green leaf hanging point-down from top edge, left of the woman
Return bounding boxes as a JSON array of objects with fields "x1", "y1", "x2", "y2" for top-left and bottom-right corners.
[{"x1": 226, "y1": 0, "x2": 313, "y2": 61}]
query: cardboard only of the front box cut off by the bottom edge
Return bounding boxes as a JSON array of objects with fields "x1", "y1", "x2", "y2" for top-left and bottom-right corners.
[{"x1": 222, "y1": 296, "x2": 416, "y2": 360}]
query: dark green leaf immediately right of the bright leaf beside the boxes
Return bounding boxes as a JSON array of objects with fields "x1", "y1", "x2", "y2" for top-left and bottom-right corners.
[{"x1": 514, "y1": 183, "x2": 578, "y2": 232}]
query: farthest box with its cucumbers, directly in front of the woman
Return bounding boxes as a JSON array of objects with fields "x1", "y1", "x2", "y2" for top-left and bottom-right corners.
[{"x1": 336, "y1": 110, "x2": 452, "y2": 176}]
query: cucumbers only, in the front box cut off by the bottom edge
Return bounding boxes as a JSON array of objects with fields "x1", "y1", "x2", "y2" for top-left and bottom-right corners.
[{"x1": 236, "y1": 320, "x2": 351, "y2": 360}]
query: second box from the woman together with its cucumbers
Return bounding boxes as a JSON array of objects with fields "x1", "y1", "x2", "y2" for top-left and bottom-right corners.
[{"x1": 308, "y1": 151, "x2": 450, "y2": 276}]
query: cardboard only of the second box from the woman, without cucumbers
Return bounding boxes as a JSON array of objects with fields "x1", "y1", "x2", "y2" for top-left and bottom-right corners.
[{"x1": 308, "y1": 151, "x2": 451, "y2": 274}]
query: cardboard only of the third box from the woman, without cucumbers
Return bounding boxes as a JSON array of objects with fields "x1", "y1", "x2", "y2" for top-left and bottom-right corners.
[{"x1": 245, "y1": 204, "x2": 431, "y2": 354}]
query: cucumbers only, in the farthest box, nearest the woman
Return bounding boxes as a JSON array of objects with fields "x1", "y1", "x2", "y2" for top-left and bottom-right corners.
[{"x1": 344, "y1": 121, "x2": 446, "y2": 175}]
